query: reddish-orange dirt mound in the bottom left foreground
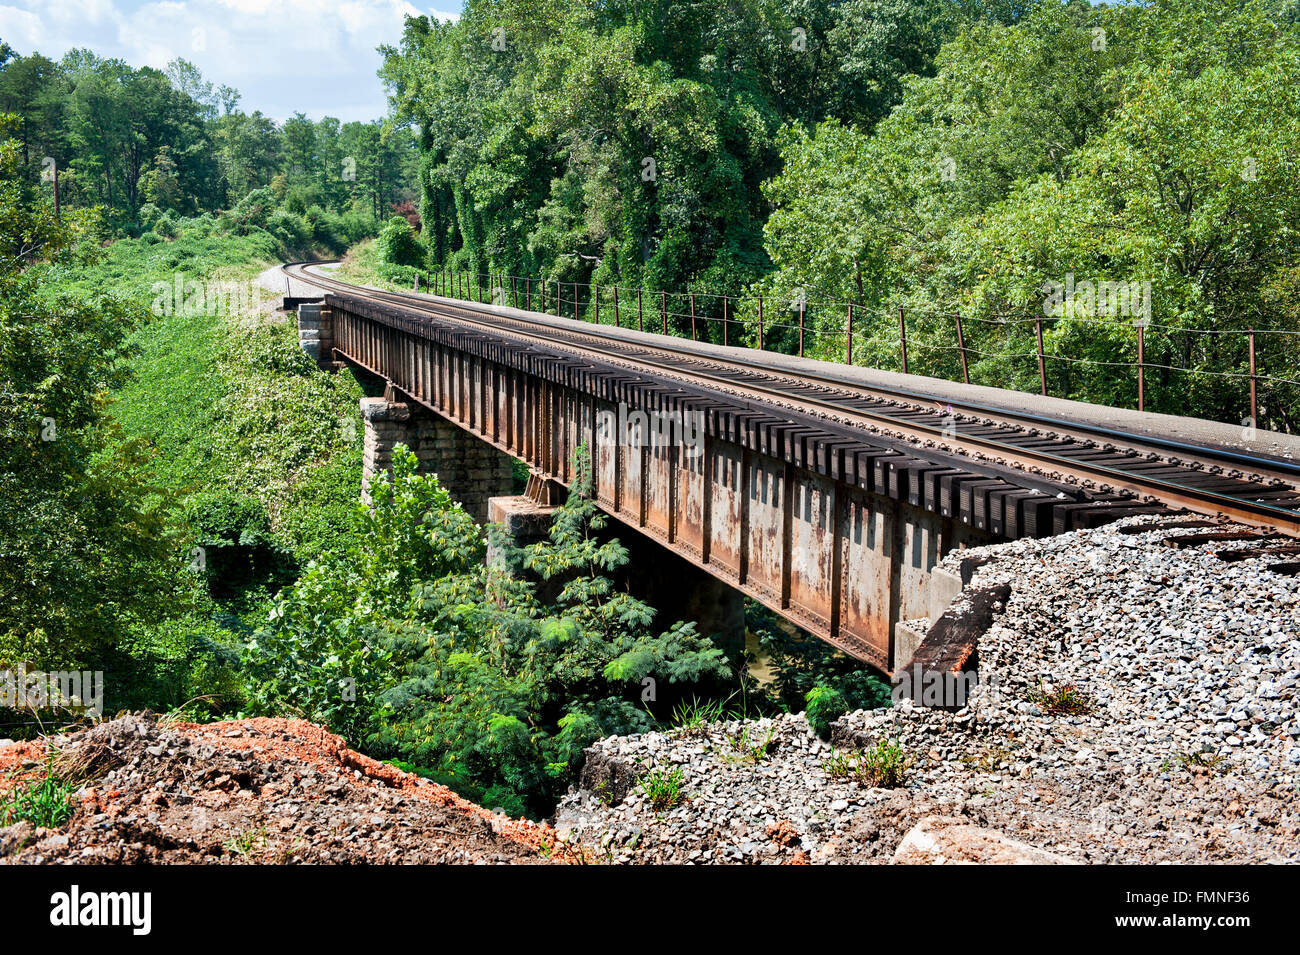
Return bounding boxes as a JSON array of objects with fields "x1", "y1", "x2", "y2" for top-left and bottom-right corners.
[{"x1": 0, "y1": 715, "x2": 569, "y2": 864}]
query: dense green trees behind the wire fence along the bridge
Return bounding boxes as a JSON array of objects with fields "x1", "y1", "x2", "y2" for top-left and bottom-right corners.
[{"x1": 384, "y1": 0, "x2": 1300, "y2": 430}]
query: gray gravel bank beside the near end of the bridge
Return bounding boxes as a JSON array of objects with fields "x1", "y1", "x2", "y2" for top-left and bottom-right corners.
[{"x1": 555, "y1": 518, "x2": 1300, "y2": 863}]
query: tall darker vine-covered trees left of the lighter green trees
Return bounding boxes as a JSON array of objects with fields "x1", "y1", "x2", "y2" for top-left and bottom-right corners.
[{"x1": 371, "y1": 0, "x2": 972, "y2": 328}]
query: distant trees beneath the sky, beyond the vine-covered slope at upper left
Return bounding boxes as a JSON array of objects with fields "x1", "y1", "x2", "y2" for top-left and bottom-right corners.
[{"x1": 0, "y1": 44, "x2": 416, "y2": 244}]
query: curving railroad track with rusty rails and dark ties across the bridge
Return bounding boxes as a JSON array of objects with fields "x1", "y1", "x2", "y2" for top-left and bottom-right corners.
[{"x1": 285, "y1": 264, "x2": 1300, "y2": 537}]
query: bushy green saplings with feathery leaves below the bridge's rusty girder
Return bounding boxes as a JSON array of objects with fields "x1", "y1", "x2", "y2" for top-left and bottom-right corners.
[{"x1": 246, "y1": 447, "x2": 729, "y2": 815}]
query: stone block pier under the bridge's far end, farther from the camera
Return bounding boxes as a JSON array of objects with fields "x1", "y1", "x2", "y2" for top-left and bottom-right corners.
[{"x1": 361, "y1": 398, "x2": 515, "y2": 524}]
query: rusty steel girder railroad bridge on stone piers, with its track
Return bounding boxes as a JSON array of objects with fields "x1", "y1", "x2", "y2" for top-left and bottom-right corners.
[{"x1": 286, "y1": 265, "x2": 1300, "y2": 672}]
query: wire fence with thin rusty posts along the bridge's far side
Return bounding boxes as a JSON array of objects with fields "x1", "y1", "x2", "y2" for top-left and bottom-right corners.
[{"x1": 413, "y1": 270, "x2": 1300, "y2": 430}]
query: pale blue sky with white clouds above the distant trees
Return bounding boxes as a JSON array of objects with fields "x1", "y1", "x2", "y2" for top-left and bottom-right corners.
[{"x1": 0, "y1": 0, "x2": 462, "y2": 122}]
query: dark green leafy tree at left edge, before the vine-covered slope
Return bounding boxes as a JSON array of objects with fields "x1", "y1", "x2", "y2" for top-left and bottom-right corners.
[{"x1": 0, "y1": 121, "x2": 185, "y2": 669}]
